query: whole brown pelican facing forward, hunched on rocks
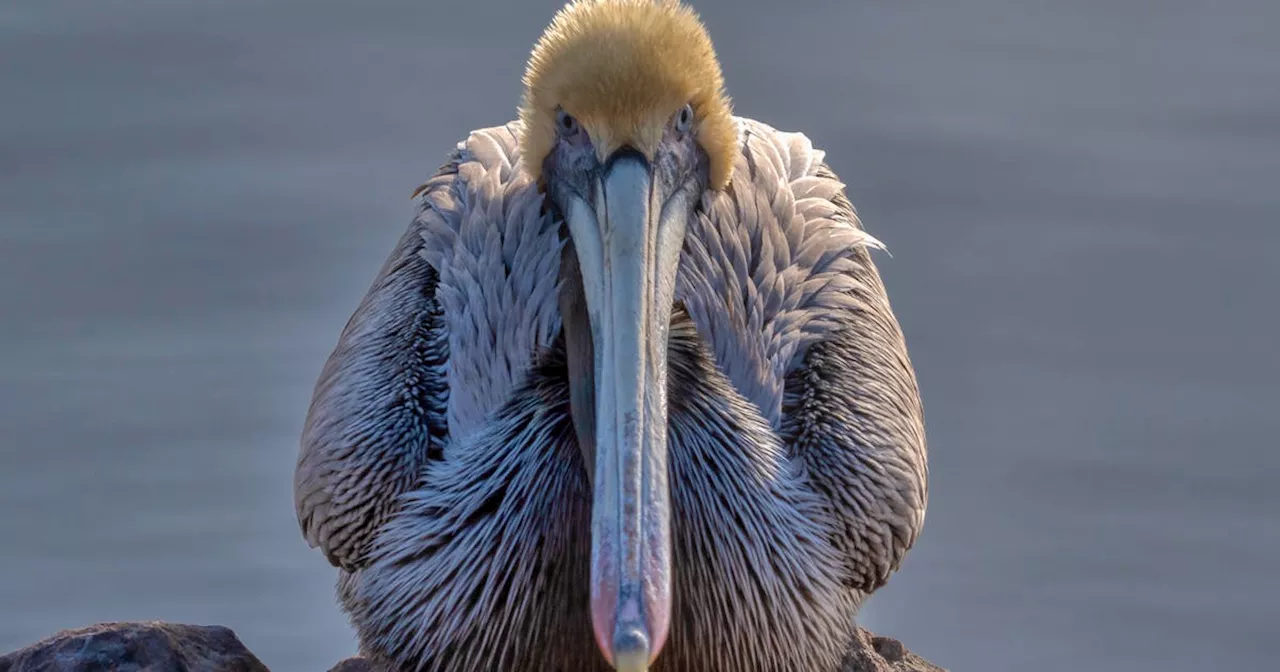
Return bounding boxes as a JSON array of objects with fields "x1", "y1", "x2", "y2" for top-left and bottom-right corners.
[{"x1": 294, "y1": 0, "x2": 927, "y2": 672}]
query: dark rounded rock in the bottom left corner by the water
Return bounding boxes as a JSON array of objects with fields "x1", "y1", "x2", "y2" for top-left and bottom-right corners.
[{"x1": 0, "y1": 622, "x2": 268, "y2": 672}]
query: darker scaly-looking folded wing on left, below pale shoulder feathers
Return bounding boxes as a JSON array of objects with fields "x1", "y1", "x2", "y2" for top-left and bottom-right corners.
[{"x1": 293, "y1": 227, "x2": 448, "y2": 570}]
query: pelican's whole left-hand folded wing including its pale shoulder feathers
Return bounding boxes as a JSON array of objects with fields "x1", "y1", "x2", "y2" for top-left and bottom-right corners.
[{"x1": 294, "y1": 124, "x2": 562, "y2": 571}]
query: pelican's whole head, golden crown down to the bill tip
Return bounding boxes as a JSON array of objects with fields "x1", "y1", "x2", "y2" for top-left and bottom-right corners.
[{"x1": 520, "y1": 0, "x2": 737, "y2": 672}]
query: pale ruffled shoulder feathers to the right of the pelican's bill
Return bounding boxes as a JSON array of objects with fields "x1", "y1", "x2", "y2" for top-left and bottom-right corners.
[{"x1": 676, "y1": 118, "x2": 879, "y2": 426}]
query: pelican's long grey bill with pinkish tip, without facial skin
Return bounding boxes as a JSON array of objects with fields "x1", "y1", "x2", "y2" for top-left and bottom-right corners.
[{"x1": 566, "y1": 150, "x2": 685, "y2": 672}]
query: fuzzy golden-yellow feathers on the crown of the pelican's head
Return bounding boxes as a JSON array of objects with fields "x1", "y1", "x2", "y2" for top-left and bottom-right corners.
[{"x1": 520, "y1": 0, "x2": 737, "y2": 189}]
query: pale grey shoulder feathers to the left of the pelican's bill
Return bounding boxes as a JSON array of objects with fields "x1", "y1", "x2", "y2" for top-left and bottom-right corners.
[{"x1": 412, "y1": 122, "x2": 563, "y2": 442}]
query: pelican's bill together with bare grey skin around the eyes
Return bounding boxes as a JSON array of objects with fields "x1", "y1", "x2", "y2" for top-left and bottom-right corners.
[{"x1": 543, "y1": 105, "x2": 708, "y2": 672}]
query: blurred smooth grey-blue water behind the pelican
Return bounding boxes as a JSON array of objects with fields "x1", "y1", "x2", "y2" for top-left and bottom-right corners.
[{"x1": 0, "y1": 0, "x2": 1280, "y2": 672}]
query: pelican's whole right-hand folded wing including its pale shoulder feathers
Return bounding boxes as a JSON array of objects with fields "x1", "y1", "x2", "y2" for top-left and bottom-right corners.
[{"x1": 677, "y1": 119, "x2": 928, "y2": 591}]
